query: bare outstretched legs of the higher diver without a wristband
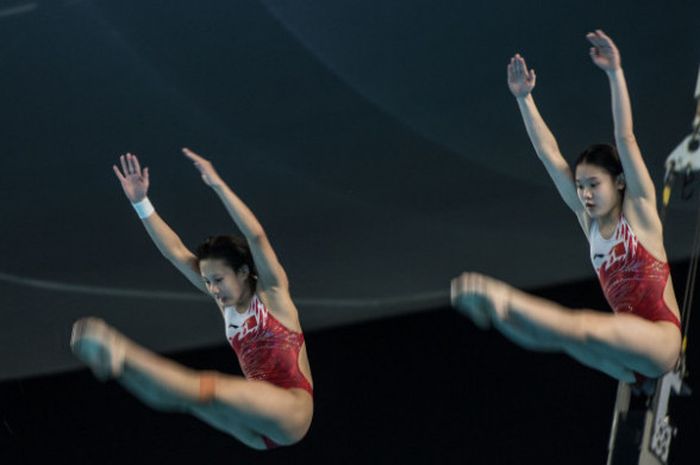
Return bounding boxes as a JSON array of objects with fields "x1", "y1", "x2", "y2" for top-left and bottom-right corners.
[{"x1": 452, "y1": 273, "x2": 680, "y2": 382}]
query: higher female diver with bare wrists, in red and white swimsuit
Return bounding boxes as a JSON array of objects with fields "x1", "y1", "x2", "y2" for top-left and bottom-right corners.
[{"x1": 451, "y1": 30, "x2": 681, "y2": 383}]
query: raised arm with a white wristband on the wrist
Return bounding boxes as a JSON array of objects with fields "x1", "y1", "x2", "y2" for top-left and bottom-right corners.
[{"x1": 112, "y1": 153, "x2": 209, "y2": 294}]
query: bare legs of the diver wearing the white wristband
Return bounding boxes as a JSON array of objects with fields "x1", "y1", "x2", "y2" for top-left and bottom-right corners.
[{"x1": 73, "y1": 319, "x2": 313, "y2": 449}]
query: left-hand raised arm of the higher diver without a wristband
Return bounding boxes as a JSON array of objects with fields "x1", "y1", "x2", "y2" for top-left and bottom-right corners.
[{"x1": 508, "y1": 54, "x2": 586, "y2": 217}]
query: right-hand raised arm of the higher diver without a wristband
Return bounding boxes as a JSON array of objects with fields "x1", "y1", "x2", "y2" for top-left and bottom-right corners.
[{"x1": 586, "y1": 30, "x2": 656, "y2": 200}]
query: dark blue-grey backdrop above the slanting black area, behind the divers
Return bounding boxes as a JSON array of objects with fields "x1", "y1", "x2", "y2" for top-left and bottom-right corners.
[{"x1": 0, "y1": 0, "x2": 700, "y2": 379}]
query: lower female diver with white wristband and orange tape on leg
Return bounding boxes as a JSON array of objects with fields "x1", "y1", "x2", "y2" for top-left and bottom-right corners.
[{"x1": 71, "y1": 149, "x2": 313, "y2": 449}]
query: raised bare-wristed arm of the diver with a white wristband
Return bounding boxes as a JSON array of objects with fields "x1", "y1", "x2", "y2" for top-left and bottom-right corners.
[{"x1": 182, "y1": 148, "x2": 289, "y2": 290}]
